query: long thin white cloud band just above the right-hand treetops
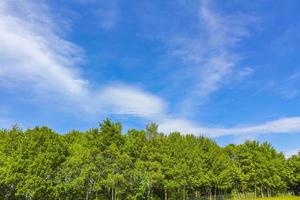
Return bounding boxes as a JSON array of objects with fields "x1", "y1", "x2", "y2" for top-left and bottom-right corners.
[{"x1": 160, "y1": 117, "x2": 300, "y2": 137}]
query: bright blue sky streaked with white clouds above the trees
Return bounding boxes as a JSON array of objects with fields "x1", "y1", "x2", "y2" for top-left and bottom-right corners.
[{"x1": 0, "y1": 0, "x2": 300, "y2": 155}]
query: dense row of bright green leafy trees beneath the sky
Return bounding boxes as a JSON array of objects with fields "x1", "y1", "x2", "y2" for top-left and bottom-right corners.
[{"x1": 0, "y1": 119, "x2": 300, "y2": 200}]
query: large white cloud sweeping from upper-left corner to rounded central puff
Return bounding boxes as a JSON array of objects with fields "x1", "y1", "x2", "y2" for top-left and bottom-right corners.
[{"x1": 0, "y1": 0, "x2": 165, "y2": 118}]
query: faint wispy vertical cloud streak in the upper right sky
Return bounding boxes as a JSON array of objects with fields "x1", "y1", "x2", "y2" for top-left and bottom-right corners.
[{"x1": 197, "y1": 1, "x2": 255, "y2": 97}]
